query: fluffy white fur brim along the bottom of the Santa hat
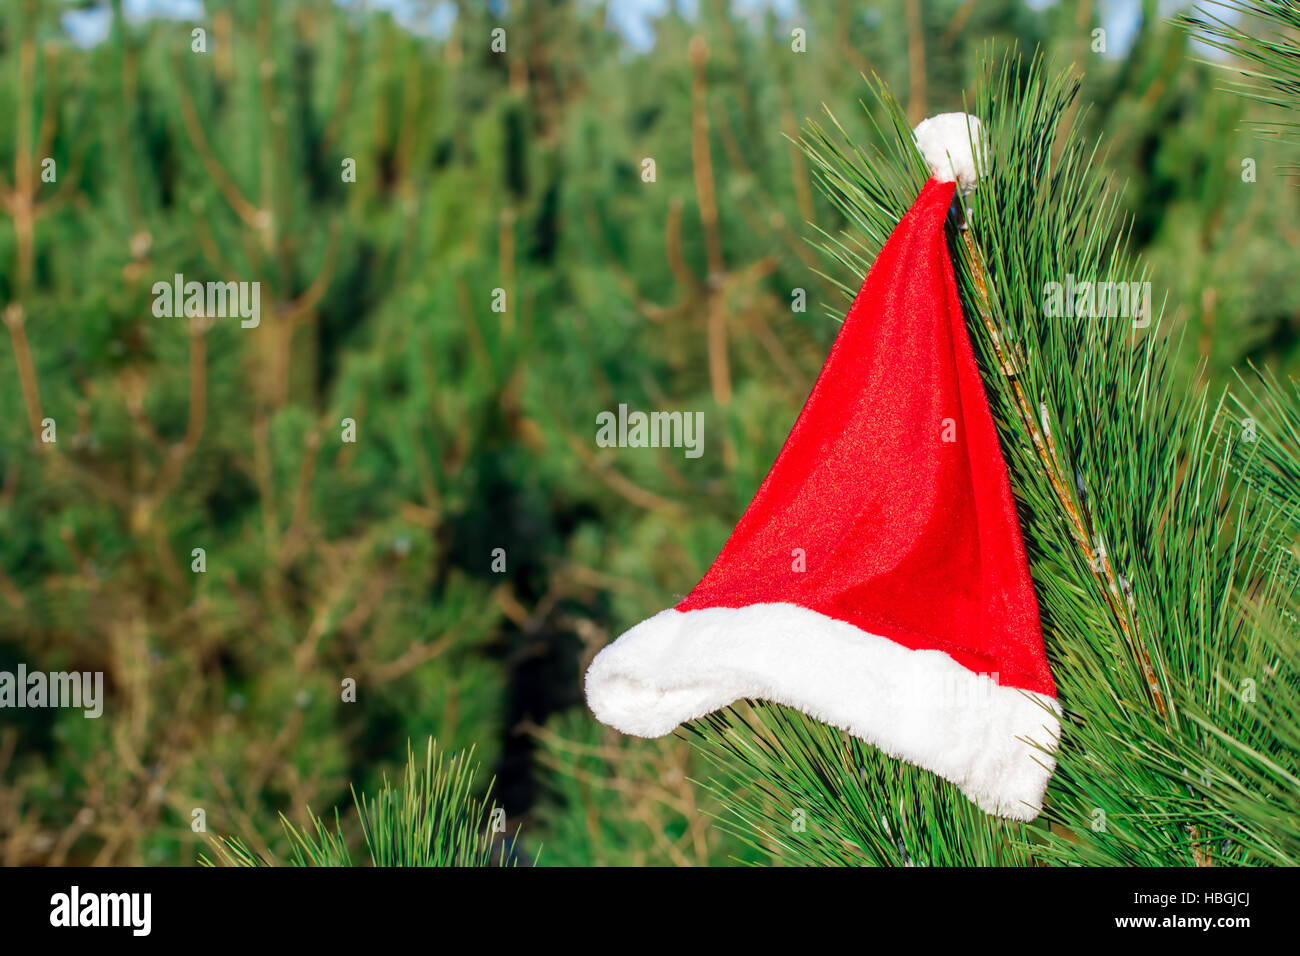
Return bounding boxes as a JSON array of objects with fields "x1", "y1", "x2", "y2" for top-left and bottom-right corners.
[{"x1": 586, "y1": 602, "x2": 1061, "y2": 821}]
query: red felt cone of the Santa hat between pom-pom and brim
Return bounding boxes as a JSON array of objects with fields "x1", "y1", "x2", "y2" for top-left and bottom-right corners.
[{"x1": 677, "y1": 179, "x2": 1056, "y2": 696}]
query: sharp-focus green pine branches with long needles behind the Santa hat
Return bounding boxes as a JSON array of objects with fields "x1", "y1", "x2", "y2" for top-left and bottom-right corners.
[{"x1": 694, "y1": 57, "x2": 1300, "y2": 865}]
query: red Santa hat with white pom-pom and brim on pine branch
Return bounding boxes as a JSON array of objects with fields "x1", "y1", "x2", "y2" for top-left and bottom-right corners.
[{"x1": 586, "y1": 113, "x2": 1061, "y2": 819}]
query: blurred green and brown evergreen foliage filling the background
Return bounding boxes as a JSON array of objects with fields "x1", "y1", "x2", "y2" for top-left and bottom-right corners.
[{"x1": 0, "y1": 0, "x2": 1300, "y2": 864}]
